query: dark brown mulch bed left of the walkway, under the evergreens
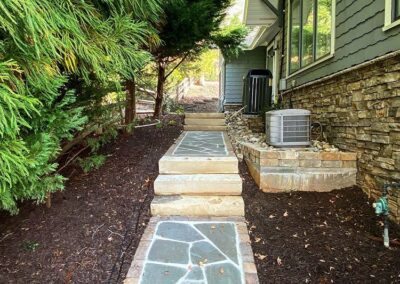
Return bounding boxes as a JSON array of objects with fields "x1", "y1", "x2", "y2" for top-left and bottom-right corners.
[{"x1": 0, "y1": 117, "x2": 181, "y2": 283}]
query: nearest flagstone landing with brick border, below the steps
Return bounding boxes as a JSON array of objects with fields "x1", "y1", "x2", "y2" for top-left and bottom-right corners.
[{"x1": 125, "y1": 217, "x2": 258, "y2": 284}]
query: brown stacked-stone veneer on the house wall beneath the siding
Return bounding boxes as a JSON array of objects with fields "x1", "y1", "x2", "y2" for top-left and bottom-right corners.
[{"x1": 283, "y1": 55, "x2": 400, "y2": 222}]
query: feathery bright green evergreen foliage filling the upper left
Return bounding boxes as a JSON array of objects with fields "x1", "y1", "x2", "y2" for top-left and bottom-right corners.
[{"x1": 0, "y1": 0, "x2": 161, "y2": 213}]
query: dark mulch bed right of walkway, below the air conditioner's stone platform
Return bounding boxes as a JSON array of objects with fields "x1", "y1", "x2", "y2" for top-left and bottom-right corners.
[{"x1": 241, "y1": 163, "x2": 400, "y2": 283}]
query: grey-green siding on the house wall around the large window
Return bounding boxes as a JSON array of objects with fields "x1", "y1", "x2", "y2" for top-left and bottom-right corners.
[{"x1": 283, "y1": 0, "x2": 400, "y2": 87}]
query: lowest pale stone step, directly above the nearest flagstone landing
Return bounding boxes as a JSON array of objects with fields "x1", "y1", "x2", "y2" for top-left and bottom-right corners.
[{"x1": 151, "y1": 195, "x2": 244, "y2": 217}]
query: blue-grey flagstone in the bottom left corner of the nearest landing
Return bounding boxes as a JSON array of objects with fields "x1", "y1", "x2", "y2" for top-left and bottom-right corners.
[{"x1": 140, "y1": 263, "x2": 187, "y2": 284}]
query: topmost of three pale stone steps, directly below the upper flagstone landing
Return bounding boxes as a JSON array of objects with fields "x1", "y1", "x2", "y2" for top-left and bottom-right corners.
[{"x1": 158, "y1": 156, "x2": 239, "y2": 174}]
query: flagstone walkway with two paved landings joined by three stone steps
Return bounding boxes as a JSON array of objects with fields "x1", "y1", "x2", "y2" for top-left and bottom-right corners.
[{"x1": 125, "y1": 117, "x2": 258, "y2": 284}]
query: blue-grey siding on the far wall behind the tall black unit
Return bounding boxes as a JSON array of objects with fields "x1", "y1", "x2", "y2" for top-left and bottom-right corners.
[{"x1": 224, "y1": 46, "x2": 266, "y2": 104}]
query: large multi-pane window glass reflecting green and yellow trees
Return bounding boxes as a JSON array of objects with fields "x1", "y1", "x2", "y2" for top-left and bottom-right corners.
[{"x1": 289, "y1": 0, "x2": 332, "y2": 73}]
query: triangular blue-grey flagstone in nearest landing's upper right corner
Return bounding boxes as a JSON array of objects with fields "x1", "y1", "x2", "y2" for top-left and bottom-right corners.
[{"x1": 195, "y1": 223, "x2": 239, "y2": 264}]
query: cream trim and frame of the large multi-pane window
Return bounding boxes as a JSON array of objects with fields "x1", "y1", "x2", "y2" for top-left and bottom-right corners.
[{"x1": 285, "y1": 0, "x2": 336, "y2": 78}]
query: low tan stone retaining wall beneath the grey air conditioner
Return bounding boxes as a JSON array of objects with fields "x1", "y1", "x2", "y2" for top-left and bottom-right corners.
[{"x1": 242, "y1": 143, "x2": 357, "y2": 192}]
